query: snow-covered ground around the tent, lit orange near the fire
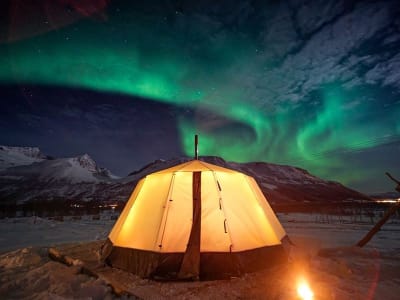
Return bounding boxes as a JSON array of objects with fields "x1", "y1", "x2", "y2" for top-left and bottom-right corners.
[{"x1": 0, "y1": 213, "x2": 400, "y2": 300}]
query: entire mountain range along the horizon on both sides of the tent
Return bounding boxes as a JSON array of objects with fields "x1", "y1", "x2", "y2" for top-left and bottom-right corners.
[{"x1": 0, "y1": 146, "x2": 369, "y2": 207}]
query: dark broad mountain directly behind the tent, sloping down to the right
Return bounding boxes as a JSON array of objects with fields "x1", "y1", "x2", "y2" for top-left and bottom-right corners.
[{"x1": 125, "y1": 156, "x2": 371, "y2": 209}]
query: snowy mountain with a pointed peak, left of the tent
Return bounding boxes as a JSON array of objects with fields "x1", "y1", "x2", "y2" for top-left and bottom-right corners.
[{"x1": 0, "y1": 148, "x2": 118, "y2": 204}]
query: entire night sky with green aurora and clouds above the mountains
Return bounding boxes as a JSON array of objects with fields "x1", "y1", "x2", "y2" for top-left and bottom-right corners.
[{"x1": 0, "y1": 0, "x2": 400, "y2": 192}]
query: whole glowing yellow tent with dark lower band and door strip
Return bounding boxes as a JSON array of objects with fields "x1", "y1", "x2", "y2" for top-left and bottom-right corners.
[{"x1": 102, "y1": 160, "x2": 287, "y2": 279}]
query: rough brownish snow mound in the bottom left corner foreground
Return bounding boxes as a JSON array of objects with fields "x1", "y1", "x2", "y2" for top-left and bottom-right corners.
[{"x1": 0, "y1": 248, "x2": 112, "y2": 299}]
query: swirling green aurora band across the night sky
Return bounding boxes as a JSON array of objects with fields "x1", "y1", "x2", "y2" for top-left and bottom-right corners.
[{"x1": 0, "y1": 4, "x2": 400, "y2": 192}]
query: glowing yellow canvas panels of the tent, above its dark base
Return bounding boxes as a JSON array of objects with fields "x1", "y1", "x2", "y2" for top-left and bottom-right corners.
[{"x1": 109, "y1": 160, "x2": 286, "y2": 253}]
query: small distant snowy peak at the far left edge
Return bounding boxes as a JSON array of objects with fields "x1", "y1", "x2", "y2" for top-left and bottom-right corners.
[{"x1": 0, "y1": 145, "x2": 49, "y2": 170}]
